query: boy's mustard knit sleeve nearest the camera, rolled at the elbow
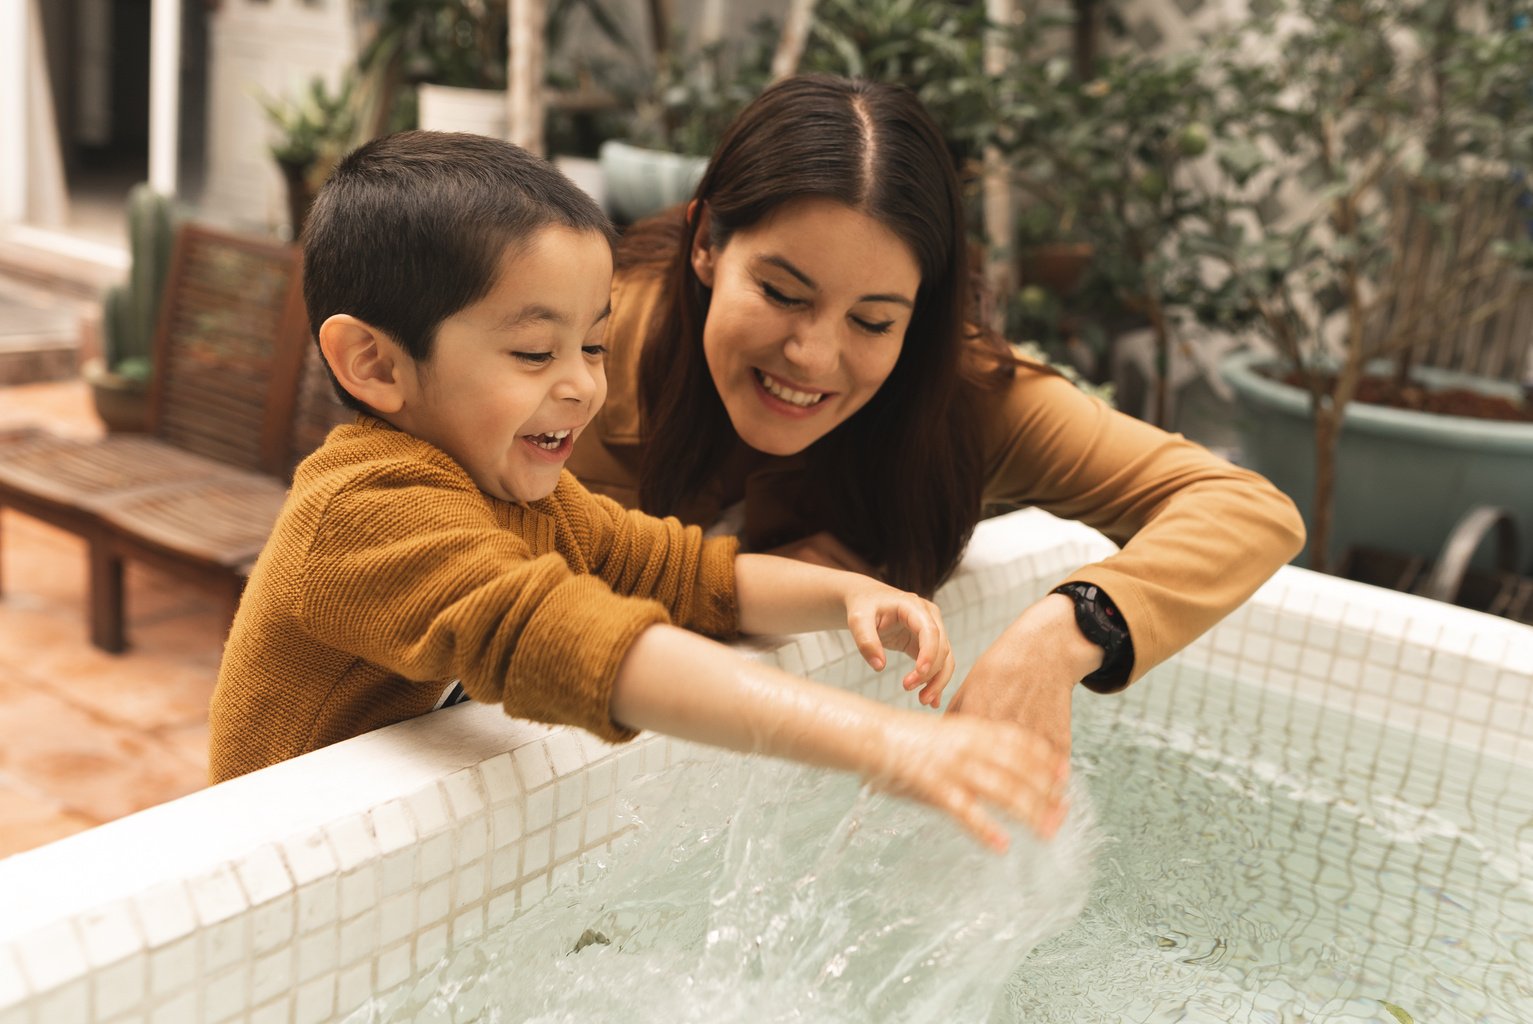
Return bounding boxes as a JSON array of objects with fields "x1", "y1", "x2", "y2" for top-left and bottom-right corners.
[{"x1": 299, "y1": 461, "x2": 667, "y2": 740}]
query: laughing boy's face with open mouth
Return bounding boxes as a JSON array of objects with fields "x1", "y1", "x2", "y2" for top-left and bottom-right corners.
[{"x1": 389, "y1": 227, "x2": 612, "y2": 501}]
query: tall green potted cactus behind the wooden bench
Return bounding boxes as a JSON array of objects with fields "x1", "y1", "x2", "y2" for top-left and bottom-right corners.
[{"x1": 81, "y1": 182, "x2": 176, "y2": 432}]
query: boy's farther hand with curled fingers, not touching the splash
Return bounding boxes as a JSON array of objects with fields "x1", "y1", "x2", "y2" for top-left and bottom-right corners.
[{"x1": 846, "y1": 578, "x2": 954, "y2": 708}]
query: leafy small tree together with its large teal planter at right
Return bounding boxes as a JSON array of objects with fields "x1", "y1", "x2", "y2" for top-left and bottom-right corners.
[{"x1": 1188, "y1": 0, "x2": 1533, "y2": 569}]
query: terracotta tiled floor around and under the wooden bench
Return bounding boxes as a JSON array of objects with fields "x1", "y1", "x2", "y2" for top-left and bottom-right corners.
[{"x1": 0, "y1": 380, "x2": 230, "y2": 855}]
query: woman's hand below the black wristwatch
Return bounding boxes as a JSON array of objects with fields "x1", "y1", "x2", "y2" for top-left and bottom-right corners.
[{"x1": 947, "y1": 593, "x2": 1102, "y2": 756}]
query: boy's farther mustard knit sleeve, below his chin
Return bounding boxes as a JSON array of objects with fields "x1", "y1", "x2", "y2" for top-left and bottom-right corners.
[{"x1": 555, "y1": 474, "x2": 739, "y2": 636}]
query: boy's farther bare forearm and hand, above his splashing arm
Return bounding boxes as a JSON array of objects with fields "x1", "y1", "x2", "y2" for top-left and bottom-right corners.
[{"x1": 734, "y1": 555, "x2": 954, "y2": 707}]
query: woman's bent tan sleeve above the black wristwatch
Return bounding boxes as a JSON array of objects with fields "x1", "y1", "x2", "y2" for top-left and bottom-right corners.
[{"x1": 986, "y1": 366, "x2": 1305, "y2": 685}]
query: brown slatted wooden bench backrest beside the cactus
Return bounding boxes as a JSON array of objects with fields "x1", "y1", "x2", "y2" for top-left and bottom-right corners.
[{"x1": 150, "y1": 224, "x2": 308, "y2": 475}]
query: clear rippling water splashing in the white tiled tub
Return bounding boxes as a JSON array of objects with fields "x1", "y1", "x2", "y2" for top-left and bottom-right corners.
[{"x1": 353, "y1": 671, "x2": 1533, "y2": 1024}]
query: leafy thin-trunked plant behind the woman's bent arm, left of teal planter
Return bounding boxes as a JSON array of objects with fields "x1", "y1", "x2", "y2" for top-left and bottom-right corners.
[{"x1": 998, "y1": 33, "x2": 1223, "y2": 423}]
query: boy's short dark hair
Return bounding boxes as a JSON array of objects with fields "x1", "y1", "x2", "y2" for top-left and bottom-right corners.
[{"x1": 304, "y1": 132, "x2": 613, "y2": 409}]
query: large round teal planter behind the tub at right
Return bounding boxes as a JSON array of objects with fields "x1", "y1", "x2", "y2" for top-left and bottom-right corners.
[{"x1": 1220, "y1": 353, "x2": 1533, "y2": 572}]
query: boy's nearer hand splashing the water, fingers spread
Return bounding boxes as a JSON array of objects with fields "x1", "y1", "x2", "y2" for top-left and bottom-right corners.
[{"x1": 865, "y1": 711, "x2": 1069, "y2": 852}]
